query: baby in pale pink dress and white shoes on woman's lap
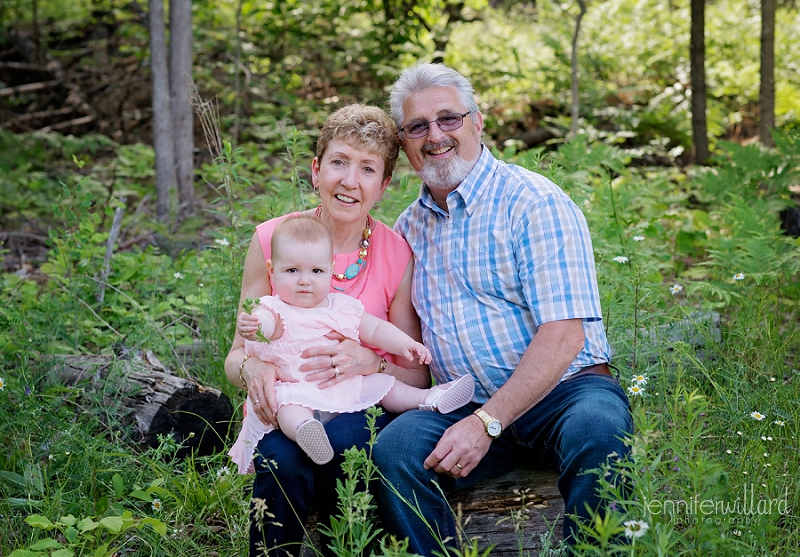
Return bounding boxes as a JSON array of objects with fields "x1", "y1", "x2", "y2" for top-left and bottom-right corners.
[{"x1": 228, "y1": 216, "x2": 475, "y2": 474}]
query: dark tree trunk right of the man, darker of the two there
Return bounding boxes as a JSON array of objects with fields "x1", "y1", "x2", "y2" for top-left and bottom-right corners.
[{"x1": 689, "y1": 0, "x2": 709, "y2": 164}]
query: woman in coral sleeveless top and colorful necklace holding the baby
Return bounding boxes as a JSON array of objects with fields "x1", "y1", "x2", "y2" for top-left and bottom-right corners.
[{"x1": 225, "y1": 105, "x2": 430, "y2": 556}]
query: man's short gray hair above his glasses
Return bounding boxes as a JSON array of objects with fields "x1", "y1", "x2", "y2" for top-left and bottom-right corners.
[{"x1": 389, "y1": 63, "x2": 480, "y2": 128}]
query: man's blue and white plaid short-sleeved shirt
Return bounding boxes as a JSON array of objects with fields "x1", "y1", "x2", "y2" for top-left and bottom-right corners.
[{"x1": 395, "y1": 147, "x2": 610, "y2": 403}]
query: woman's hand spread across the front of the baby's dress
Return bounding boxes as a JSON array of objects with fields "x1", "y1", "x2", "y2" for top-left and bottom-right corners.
[{"x1": 299, "y1": 332, "x2": 381, "y2": 389}]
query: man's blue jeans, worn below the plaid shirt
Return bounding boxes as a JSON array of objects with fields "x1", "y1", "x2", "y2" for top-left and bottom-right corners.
[{"x1": 373, "y1": 375, "x2": 633, "y2": 555}]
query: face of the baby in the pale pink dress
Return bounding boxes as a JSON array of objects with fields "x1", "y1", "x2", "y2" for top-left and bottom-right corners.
[{"x1": 271, "y1": 240, "x2": 333, "y2": 308}]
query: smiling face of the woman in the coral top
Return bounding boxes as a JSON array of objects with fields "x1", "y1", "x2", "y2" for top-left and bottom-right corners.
[{"x1": 311, "y1": 139, "x2": 391, "y2": 223}]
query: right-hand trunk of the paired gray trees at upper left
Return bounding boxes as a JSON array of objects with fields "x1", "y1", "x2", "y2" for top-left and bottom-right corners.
[{"x1": 169, "y1": 0, "x2": 194, "y2": 214}]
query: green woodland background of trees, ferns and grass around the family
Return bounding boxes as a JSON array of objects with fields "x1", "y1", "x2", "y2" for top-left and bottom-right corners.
[{"x1": 0, "y1": 0, "x2": 800, "y2": 557}]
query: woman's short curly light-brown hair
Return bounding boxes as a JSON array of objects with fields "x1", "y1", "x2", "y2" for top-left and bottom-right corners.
[{"x1": 317, "y1": 104, "x2": 400, "y2": 179}]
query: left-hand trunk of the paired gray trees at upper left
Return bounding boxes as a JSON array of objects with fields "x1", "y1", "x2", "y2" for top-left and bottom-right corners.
[{"x1": 150, "y1": 0, "x2": 177, "y2": 223}]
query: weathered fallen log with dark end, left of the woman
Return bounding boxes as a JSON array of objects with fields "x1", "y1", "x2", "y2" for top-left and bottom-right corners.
[{"x1": 50, "y1": 351, "x2": 233, "y2": 457}]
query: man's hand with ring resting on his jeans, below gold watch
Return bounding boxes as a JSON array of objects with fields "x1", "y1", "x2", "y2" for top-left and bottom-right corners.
[{"x1": 424, "y1": 415, "x2": 492, "y2": 478}]
